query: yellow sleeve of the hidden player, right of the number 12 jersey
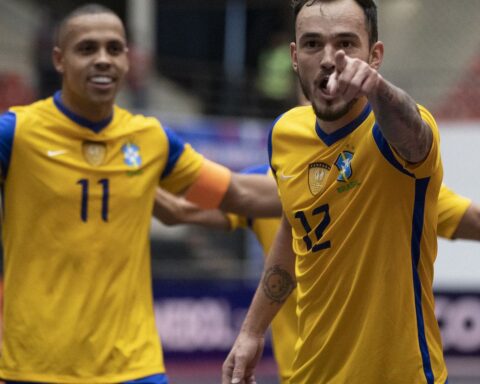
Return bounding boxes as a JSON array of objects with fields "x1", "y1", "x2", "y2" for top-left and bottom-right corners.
[{"x1": 437, "y1": 184, "x2": 472, "y2": 239}]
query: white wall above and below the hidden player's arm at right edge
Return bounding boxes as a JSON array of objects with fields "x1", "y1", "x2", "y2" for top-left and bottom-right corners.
[{"x1": 434, "y1": 121, "x2": 480, "y2": 291}]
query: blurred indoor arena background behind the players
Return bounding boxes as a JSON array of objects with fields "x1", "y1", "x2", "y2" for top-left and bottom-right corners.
[{"x1": 0, "y1": 0, "x2": 480, "y2": 384}]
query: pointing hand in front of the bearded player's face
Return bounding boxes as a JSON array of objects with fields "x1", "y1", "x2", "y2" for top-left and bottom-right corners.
[{"x1": 327, "y1": 51, "x2": 382, "y2": 102}]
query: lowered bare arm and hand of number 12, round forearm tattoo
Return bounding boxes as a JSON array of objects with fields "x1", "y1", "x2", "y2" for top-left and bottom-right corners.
[{"x1": 222, "y1": 217, "x2": 296, "y2": 384}]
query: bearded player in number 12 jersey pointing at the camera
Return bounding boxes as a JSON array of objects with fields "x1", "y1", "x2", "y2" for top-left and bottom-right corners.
[{"x1": 222, "y1": 0, "x2": 447, "y2": 384}]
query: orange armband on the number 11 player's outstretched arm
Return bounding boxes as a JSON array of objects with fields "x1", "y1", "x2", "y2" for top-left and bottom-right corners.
[{"x1": 185, "y1": 159, "x2": 232, "y2": 209}]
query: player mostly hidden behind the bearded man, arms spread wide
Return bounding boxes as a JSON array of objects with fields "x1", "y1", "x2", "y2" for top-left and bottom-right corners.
[{"x1": 153, "y1": 178, "x2": 480, "y2": 384}]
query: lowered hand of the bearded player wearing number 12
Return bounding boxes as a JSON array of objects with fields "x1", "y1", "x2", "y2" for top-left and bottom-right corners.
[{"x1": 222, "y1": 331, "x2": 265, "y2": 384}]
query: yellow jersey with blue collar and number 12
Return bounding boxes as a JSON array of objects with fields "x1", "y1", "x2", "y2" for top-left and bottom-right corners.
[{"x1": 269, "y1": 105, "x2": 447, "y2": 384}]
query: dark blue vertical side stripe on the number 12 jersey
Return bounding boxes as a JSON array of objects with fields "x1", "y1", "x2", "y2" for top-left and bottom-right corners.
[{"x1": 411, "y1": 178, "x2": 435, "y2": 384}]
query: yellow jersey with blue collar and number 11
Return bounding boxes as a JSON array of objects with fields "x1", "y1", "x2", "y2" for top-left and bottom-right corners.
[{"x1": 0, "y1": 93, "x2": 203, "y2": 384}]
